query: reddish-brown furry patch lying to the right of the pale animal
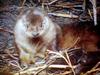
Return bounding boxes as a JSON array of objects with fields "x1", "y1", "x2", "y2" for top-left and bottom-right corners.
[{"x1": 58, "y1": 25, "x2": 99, "y2": 52}]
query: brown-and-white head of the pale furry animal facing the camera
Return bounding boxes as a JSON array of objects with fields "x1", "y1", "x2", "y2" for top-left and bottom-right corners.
[{"x1": 22, "y1": 9, "x2": 49, "y2": 38}]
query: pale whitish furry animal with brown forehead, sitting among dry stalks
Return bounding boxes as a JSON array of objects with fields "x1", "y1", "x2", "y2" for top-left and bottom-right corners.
[{"x1": 14, "y1": 8, "x2": 60, "y2": 64}]
